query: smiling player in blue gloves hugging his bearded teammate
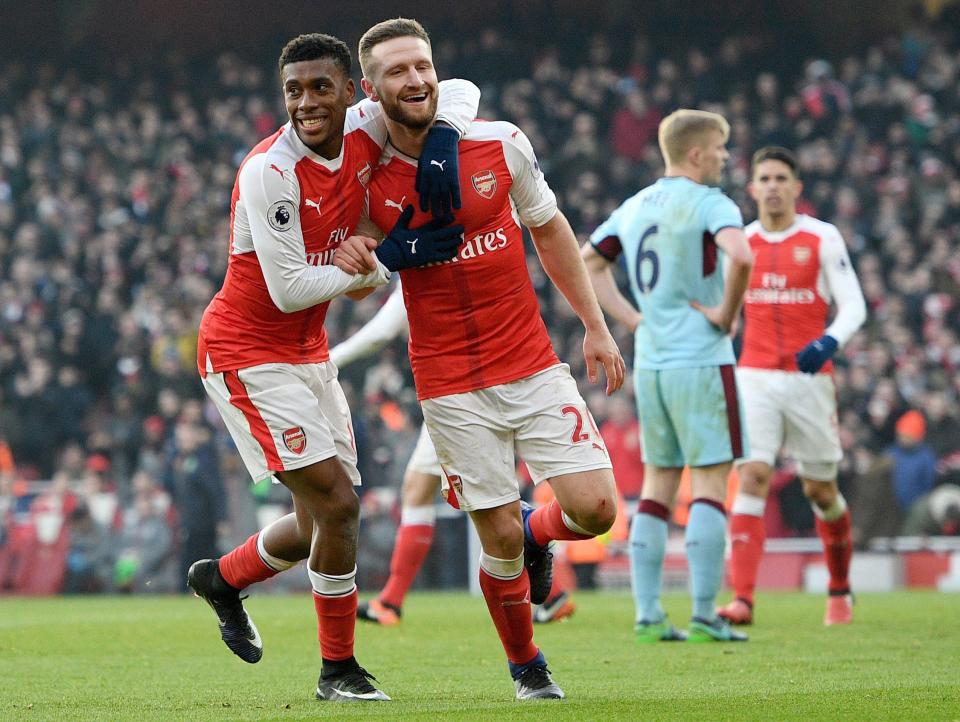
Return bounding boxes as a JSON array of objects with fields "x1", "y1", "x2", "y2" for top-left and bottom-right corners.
[{"x1": 188, "y1": 34, "x2": 479, "y2": 701}]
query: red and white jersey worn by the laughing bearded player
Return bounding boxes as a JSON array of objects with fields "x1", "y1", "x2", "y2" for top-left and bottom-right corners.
[{"x1": 368, "y1": 121, "x2": 559, "y2": 400}]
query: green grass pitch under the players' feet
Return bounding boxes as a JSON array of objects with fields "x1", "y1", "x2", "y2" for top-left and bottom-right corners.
[{"x1": 0, "y1": 592, "x2": 960, "y2": 722}]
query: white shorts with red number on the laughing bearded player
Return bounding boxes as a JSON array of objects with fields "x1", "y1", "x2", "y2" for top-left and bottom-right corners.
[{"x1": 422, "y1": 364, "x2": 611, "y2": 511}]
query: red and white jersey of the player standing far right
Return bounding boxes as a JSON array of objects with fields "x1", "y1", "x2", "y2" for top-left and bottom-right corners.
[{"x1": 740, "y1": 214, "x2": 867, "y2": 373}]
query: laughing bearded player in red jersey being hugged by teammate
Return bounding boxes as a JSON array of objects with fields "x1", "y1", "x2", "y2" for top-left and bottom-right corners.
[{"x1": 338, "y1": 19, "x2": 624, "y2": 699}]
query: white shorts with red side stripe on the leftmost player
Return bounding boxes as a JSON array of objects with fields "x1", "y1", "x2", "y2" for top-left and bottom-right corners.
[{"x1": 203, "y1": 361, "x2": 360, "y2": 485}]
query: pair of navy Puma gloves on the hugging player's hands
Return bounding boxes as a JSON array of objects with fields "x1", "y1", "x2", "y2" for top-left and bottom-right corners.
[{"x1": 375, "y1": 125, "x2": 463, "y2": 271}]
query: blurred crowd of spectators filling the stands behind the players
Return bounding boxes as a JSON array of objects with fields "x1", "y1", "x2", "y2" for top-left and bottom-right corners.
[{"x1": 0, "y1": 2, "x2": 960, "y2": 592}]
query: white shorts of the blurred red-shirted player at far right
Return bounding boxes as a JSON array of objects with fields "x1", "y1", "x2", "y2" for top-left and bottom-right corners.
[{"x1": 737, "y1": 368, "x2": 843, "y2": 466}]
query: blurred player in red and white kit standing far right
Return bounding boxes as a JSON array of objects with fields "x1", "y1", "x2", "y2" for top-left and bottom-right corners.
[{"x1": 719, "y1": 147, "x2": 867, "y2": 625}]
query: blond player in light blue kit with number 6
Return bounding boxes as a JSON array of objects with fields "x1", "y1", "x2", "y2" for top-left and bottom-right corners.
[{"x1": 582, "y1": 110, "x2": 752, "y2": 642}]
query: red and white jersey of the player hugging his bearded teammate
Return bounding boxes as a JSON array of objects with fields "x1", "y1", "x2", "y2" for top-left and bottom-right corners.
[{"x1": 197, "y1": 80, "x2": 480, "y2": 375}]
